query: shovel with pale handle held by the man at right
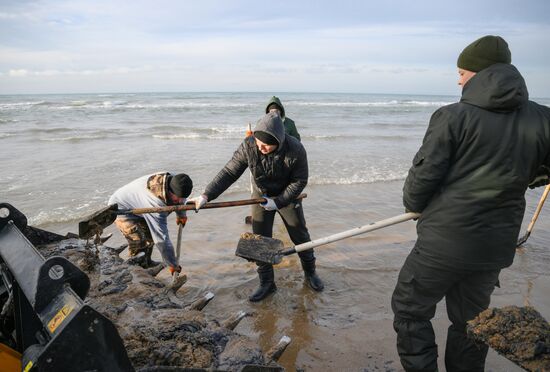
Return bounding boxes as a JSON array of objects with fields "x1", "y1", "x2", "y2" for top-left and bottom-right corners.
[{"x1": 235, "y1": 212, "x2": 420, "y2": 265}]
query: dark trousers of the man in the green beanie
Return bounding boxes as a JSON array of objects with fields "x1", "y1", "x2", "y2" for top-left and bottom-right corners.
[{"x1": 391, "y1": 248, "x2": 500, "y2": 372}]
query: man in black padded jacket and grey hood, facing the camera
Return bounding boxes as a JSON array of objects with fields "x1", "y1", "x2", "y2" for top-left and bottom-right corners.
[{"x1": 190, "y1": 112, "x2": 323, "y2": 302}]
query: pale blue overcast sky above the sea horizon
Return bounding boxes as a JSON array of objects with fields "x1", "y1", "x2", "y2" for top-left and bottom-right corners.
[{"x1": 0, "y1": 0, "x2": 550, "y2": 97}]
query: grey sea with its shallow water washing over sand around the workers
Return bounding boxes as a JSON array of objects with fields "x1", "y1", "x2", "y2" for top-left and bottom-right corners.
[{"x1": 0, "y1": 92, "x2": 550, "y2": 370}]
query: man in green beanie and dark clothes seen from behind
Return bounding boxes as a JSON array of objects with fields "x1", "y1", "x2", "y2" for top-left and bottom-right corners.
[{"x1": 392, "y1": 36, "x2": 550, "y2": 371}]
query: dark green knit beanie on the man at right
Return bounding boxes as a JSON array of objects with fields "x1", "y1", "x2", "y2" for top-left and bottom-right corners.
[{"x1": 456, "y1": 35, "x2": 512, "y2": 72}]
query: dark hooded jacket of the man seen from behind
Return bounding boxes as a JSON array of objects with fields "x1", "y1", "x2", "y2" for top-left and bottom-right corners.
[{"x1": 403, "y1": 64, "x2": 550, "y2": 270}]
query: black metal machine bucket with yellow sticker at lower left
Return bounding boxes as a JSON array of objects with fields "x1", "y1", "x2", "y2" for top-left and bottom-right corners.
[{"x1": 0, "y1": 203, "x2": 134, "y2": 372}]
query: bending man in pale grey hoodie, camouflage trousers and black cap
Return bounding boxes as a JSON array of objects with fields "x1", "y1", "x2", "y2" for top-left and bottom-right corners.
[{"x1": 109, "y1": 172, "x2": 193, "y2": 275}]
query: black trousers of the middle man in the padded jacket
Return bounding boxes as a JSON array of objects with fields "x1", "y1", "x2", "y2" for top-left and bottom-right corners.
[{"x1": 252, "y1": 193, "x2": 315, "y2": 271}]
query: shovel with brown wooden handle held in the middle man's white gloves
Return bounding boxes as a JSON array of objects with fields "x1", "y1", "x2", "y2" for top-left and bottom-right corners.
[{"x1": 78, "y1": 194, "x2": 307, "y2": 239}]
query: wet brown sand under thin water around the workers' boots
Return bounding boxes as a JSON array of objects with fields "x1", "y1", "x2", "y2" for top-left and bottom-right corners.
[{"x1": 41, "y1": 181, "x2": 550, "y2": 371}]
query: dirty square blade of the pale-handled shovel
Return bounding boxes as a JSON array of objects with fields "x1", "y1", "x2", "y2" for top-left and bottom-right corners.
[{"x1": 235, "y1": 233, "x2": 284, "y2": 265}]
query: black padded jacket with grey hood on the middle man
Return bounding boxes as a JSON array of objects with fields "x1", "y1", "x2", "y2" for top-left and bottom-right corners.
[{"x1": 204, "y1": 113, "x2": 308, "y2": 208}]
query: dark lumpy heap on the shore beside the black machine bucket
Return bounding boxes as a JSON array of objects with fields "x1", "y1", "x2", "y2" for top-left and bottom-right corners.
[{"x1": 39, "y1": 239, "x2": 283, "y2": 371}]
